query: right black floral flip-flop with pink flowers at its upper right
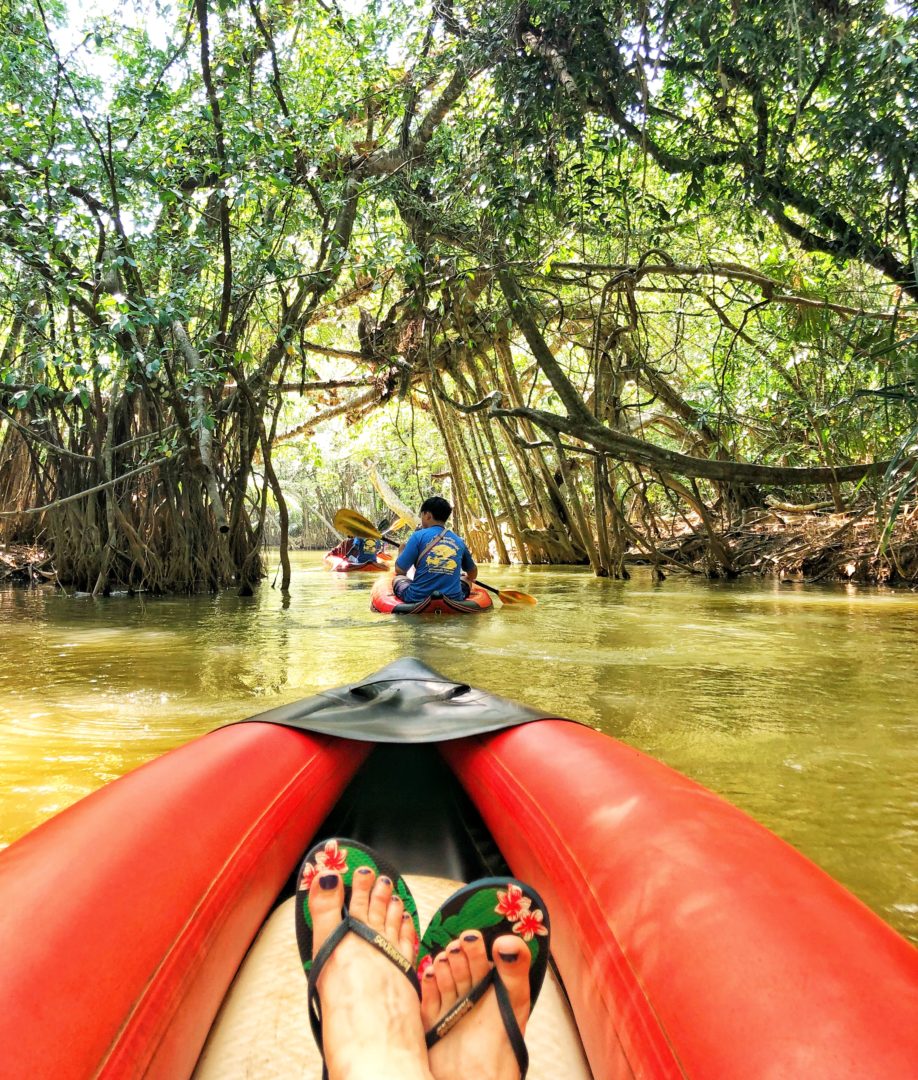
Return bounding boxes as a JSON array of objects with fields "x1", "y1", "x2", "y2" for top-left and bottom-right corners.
[{"x1": 418, "y1": 877, "x2": 551, "y2": 1080}]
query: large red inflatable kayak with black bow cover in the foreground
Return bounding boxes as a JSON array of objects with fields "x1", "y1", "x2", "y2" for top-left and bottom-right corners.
[{"x1": 0, "y1": 660, "x2": 918, "y2": 1080}]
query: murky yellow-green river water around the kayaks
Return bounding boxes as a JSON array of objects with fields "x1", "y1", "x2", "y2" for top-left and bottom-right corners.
[{"x1": 0, "y1": 553, "x2": 918, "y2": 942}]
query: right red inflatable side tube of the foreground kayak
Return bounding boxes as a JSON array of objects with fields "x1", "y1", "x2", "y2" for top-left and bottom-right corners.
[{"x1": 441, "y1": 720, "x2": 918, "y2": 1080}]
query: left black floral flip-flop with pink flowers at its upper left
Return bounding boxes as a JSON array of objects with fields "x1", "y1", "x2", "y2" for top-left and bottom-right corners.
[{"x1": 295, "y1": 837, "x2": 420, "y2": 1077}]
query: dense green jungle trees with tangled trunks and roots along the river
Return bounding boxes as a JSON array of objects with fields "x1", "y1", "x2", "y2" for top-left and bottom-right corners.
[{"x1": 0, "y1": 0, "x2": 918, "y2": 593}]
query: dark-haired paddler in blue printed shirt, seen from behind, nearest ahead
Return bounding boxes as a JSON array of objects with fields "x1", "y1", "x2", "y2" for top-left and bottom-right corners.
[{"x1": 392, "y1": 495, "x2": 478, "y2": 604}]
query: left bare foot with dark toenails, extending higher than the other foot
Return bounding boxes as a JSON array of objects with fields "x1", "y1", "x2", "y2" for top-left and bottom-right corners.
[{"x1": 309, "y1": 867, "x2": 431, "y2": 1080}]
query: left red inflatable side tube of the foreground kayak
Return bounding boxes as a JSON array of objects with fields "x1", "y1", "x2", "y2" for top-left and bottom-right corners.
[{"x1": 0, "y1": 724, "x2": 369, "y2": 1080}]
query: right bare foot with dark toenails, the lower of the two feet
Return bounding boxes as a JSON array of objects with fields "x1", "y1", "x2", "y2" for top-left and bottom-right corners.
[{"x1": 421, "y1": 930, "x2": 530, "y2": 1080}]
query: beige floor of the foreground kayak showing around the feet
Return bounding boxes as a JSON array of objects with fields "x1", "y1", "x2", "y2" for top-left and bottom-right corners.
[{"x1": 193, "y1": 875, "x2": 592, "y2": 1080}]
